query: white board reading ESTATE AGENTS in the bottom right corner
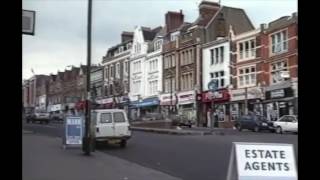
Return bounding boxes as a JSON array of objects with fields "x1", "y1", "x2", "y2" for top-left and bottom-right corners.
[{"x1": 227, "y1": 143, "x2": 298, "y2": 180}]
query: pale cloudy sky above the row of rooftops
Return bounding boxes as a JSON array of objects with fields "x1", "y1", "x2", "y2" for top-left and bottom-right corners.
[{"x1": 22, "y1": 0, "x2": 298, "y2": 79}]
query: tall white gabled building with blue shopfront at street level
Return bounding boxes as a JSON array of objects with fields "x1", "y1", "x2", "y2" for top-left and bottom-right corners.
[{"x1": 129, "y1": 26, "x2": 162, "y2": 119}]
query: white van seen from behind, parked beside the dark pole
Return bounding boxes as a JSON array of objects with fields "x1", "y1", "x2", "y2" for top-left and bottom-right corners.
[{"x1": 91, "y1": 109, "x2": 131, "y2": 147}]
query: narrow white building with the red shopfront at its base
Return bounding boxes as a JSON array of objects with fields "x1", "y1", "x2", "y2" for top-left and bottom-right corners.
[{"x1": 202, "y1": 38, "x2": 231, "y2": 124}]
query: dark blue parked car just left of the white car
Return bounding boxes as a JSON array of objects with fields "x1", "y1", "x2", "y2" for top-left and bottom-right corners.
[{"x1": 235, "y1": 115, "x2": 274, "y2": 132}]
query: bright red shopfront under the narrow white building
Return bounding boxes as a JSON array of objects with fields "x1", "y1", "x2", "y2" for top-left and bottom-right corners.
[{"x1": 201, "y1": 89, "x2": 233, "y2": 128}]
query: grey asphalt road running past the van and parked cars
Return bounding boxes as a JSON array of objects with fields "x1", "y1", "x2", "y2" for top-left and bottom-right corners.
[{"x1": 23, "y1": 121, "x2": 298, "y2": 180}]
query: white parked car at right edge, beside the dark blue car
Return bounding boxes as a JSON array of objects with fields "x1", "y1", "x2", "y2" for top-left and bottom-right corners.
[{"x1": 273, "y1": 115, "x2": 298, "y2": 134}]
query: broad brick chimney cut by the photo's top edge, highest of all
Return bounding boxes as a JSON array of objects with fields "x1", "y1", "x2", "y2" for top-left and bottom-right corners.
[{"x1": 199, "y1": 1, "x2": 220, "y2": 19}]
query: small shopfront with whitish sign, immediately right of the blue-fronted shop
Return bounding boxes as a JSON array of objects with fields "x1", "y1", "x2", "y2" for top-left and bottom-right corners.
[{"x1": 160, "y1": 93, "x2": 177, "y2": 117}]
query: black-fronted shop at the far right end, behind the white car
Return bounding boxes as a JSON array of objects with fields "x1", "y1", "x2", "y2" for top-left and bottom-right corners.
[{"x1": 264, "y1": 87, "x2": 297, "y2": 121}]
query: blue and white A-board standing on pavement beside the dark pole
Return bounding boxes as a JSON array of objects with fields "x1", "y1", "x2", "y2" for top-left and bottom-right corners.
[{"x1": 65, "y1": 116, "x2": 83, "y2": 145}]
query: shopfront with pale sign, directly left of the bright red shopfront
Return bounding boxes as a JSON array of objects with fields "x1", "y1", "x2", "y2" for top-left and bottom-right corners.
[{"x1": 177, "y1": 91, "x2": 197, "y2": 122}]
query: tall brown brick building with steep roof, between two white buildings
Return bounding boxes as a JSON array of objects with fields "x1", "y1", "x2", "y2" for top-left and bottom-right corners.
[{"x1": 163, "y1": 1, "x2": 254, "y2": 125}]
